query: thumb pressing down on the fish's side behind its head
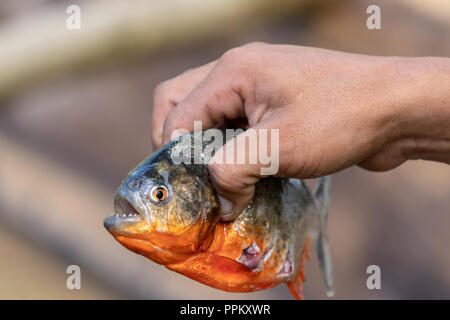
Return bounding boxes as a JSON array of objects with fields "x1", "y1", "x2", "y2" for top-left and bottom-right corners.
[{"x1": 208, "y1": 128, "x2": 278, "y2": 221}]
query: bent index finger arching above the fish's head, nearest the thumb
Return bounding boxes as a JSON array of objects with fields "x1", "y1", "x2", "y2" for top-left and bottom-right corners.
[{"x1": 162, "y1": 64, "x2": 245, "y2": 144}]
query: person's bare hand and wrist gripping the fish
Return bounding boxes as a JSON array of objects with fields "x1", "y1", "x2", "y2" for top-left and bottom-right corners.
[{"x1": 152, "y1": 43, "x2": 450, "y2": 220}]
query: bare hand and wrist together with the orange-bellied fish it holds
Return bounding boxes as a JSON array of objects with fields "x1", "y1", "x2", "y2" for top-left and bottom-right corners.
[{"x1": 104, "y1": 43, "x2": 450, "y2": 299}]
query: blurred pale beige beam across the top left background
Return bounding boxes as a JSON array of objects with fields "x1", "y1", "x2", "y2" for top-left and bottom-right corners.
[{"x1": 0, "y1": 0, "x2": 308, "y2": 99}]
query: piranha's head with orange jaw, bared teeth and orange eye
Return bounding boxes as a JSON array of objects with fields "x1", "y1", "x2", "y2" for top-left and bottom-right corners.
[{"x1": 104, "y1": 136, "x2": 220, "y2": 264}]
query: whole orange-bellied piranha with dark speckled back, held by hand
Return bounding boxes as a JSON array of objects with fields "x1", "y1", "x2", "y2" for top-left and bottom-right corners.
[{"x1": 104, "y1": 129, "x2": 334, "y2": 299}]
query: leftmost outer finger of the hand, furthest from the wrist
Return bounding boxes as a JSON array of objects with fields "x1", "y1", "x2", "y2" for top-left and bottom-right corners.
[{"x1": 152, "y1": 61, "x2": 217, "y2": 148}]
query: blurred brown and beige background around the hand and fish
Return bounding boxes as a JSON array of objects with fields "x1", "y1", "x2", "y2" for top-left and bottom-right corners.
[{"x1": 0, "y1": 0, "x2": 450, "y2": 299}]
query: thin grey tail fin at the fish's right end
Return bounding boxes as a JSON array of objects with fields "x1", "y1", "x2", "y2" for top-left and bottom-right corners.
[{"x1": 314, "y1": 176, "x2": 334, "y2": 297}]
